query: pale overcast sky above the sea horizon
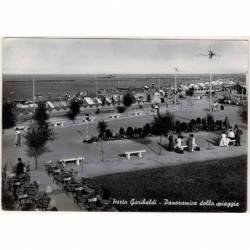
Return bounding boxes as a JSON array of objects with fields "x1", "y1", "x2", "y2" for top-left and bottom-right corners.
[{"x1": 3, "y1": 38, "x2": 249, "y2": 74}]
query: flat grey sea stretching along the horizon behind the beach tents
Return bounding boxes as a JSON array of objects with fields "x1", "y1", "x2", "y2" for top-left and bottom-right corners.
[{"x1": 2, "y1": 74, "x2": 245, "y2": 100}]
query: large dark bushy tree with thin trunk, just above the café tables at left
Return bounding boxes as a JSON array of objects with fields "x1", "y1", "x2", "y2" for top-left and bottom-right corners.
[{"x1": 24, "y1": 122, "x2": 54, "y2": 169}]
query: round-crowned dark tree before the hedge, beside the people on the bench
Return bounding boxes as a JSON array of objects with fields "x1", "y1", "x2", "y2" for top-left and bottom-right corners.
[{"x1": 152, "y1": 111, "x2": 175, "y2": 154}]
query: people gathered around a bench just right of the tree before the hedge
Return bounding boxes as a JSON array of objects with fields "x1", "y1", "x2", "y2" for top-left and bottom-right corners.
[{"x1": 168, "y1": 134, "x2": 198, "y2": 153}]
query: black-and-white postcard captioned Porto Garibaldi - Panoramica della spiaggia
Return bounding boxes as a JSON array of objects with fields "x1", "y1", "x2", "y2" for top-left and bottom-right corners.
[{"x1": 1, "y1": 38, "x2": 249, "y2": 212}]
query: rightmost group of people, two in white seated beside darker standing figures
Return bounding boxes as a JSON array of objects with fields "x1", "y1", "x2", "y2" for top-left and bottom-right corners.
[{"x1": 219, "y1": 124, "x2": 242, "y2": 147}]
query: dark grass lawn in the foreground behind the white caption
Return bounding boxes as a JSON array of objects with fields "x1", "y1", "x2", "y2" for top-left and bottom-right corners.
[{"x1": 92, "y1": 156, "x2": 247, "y2": 212}]
